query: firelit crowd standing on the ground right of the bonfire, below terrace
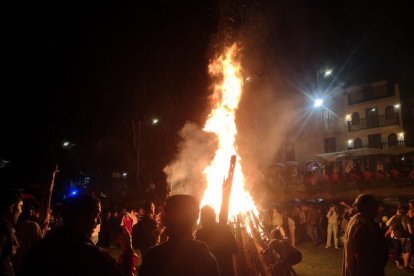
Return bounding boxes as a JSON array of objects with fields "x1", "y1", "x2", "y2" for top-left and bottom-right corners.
[{"x1": 262, "y1": 196, "x2": 414, "y2": 275}]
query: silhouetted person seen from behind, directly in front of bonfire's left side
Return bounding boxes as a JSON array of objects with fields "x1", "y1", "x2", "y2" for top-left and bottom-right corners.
[{"x1": 140, "y1": 195, "x2": 219, "y2": 276}]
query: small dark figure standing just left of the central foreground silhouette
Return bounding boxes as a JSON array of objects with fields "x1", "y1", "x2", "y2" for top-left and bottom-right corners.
[{"x1": 132, "y1": 201, "x2": 158, "y2": 256}]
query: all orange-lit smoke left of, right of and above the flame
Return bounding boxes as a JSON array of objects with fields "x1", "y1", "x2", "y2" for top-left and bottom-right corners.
[{"x1": 164, "y1": 0, "x2": 300, "y2": 203}]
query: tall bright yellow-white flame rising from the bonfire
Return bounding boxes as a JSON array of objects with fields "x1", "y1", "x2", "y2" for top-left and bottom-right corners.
[{"x1": 201, "y1": 44, "x2": 257, "y2": 219}]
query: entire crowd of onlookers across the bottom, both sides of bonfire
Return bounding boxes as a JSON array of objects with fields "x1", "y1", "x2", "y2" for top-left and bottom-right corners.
[{"x1": 0, "y1": 187, "x2": 414, "y2": 276}]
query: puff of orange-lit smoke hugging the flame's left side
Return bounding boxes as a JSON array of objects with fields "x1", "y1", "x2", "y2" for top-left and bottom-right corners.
[{"x1": 164, "y1": 122, "x2": 217, "y2": 199}]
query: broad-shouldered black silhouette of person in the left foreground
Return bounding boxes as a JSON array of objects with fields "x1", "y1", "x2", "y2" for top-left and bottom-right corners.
[{"x1": 23, "y1": 194, "x2": 132, "y2": 276}]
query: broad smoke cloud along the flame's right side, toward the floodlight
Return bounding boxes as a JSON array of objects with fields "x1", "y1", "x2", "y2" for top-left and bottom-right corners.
[{"x1": 236, "y1": 77, "x2": 299, "y2": 202}]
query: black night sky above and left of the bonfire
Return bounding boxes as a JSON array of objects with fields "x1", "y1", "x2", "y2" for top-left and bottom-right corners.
[{"x1": 0, "y1": 0, "x2": 414, "y2": 198}]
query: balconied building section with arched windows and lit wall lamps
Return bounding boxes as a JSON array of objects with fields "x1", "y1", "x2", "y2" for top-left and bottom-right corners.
[{"x1": 343, "y1": 81, "x2": 404, "y2": 149}]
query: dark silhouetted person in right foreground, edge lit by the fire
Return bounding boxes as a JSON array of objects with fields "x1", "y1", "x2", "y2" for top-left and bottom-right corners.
[{"x1": 342, "y1": 194, "x2": 387, "y2": 276}]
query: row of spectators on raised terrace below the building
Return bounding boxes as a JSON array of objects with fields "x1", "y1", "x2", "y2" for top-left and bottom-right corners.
[{"x1": 269, "y1": 154, "x2": 414, "y2": 187}]
